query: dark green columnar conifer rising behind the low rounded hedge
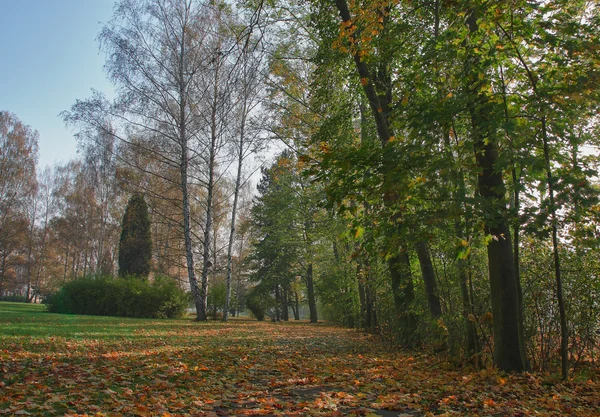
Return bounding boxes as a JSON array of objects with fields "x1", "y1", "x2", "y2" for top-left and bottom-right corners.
[{"x1": 119, "y1": 194, "x2": 152, "y2": 279}]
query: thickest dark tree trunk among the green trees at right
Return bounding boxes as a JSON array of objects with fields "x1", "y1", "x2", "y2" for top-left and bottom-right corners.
[{"x1": 465, "y1": 11, "x2": 527, "y2": 372}]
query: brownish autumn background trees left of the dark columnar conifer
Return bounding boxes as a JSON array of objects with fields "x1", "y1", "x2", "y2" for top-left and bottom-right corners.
[{"x1": 0, "y1": 112, "x2": 120, "y2": 300}]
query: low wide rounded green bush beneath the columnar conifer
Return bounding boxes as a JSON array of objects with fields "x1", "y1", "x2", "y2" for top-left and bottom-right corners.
[{"x1": 44, "y1": 277, "x2": 189, "y2": 318}]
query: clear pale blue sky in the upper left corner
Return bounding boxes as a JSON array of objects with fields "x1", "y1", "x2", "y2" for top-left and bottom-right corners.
[{"x1": 0, "y1": 0, "x2": 115, "y2": 168}]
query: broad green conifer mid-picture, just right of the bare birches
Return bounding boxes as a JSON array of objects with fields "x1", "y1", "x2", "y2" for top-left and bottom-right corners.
[{"x1": 251, "y1": 151, "x2": 321, "y2": 323}]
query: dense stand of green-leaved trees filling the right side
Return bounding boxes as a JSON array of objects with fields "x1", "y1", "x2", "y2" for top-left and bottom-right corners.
[{"x1": 243, "y1": 0, "x2": 600, "y2": 377}]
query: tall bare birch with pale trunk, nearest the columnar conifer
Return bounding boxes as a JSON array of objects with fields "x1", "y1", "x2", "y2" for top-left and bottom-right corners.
[{"x1": 65, "y1": 0, "x2": 210, "y2": 318}]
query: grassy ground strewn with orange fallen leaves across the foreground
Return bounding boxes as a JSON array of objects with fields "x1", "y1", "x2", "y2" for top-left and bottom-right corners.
[{"x1": 0, "y1": 303, "x2": 600, "y2": 417}]
